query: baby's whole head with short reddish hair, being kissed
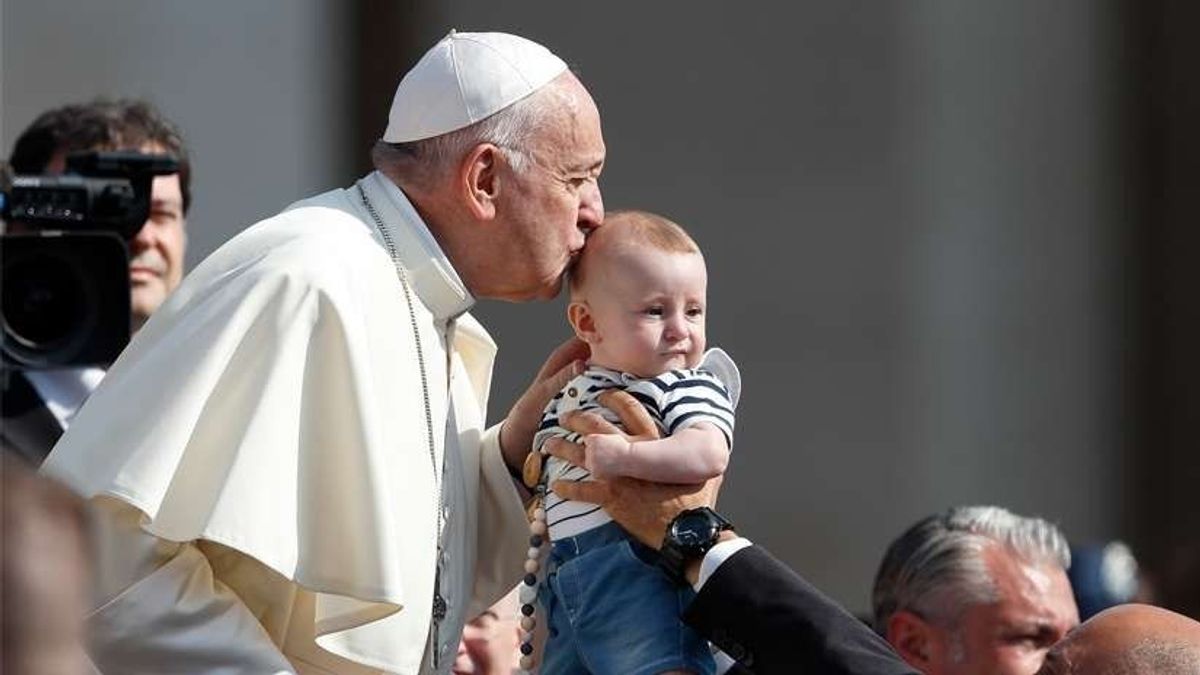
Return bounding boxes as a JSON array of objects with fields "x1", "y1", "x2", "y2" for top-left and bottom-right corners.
[{"x1": 566, "y1": 211, "x2": 708, "y2": 377}]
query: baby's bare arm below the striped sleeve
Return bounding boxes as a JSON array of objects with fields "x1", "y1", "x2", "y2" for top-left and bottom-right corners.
[{"x1": 583, "y1": 422, "x2": 730, "y2": 483}]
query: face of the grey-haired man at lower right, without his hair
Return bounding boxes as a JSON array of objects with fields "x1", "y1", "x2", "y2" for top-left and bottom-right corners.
[{"x1": 889, "y1": 545, "x2": 1079, "y2": 675}]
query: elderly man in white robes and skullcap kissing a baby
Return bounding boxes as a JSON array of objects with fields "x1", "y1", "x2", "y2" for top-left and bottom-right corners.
[{"x1": 43, "y1": 31, "x2": 605, "y2": 674}]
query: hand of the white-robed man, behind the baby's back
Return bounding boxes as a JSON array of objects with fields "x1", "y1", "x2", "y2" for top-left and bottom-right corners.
[{"x1": 500, "y1": 338, "x2": 590, "y2": 472}]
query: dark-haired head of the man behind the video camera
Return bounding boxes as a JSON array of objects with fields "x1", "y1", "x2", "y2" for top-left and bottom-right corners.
[{"x1": 10, "y1": 100, "x2": 191, "y2": 330}]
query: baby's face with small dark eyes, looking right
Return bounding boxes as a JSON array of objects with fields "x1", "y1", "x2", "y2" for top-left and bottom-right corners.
[{"x1": 583, "y1": 246, "x2": 708, "y2": 377}]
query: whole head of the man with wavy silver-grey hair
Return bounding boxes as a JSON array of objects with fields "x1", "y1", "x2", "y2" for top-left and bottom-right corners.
[{"x1": 872, "y1": 507, "x2": 1079, "y2": 675}]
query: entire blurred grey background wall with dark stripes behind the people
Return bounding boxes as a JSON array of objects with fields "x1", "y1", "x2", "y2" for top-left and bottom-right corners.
[{"x1": 0, "y1": 0, "x2": 1200, "y2": 610}]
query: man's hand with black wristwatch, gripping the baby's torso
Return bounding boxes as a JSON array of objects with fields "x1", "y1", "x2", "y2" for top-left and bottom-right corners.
[{"x1": 546, "y1": 392, "x2": 721, "y2": 549}]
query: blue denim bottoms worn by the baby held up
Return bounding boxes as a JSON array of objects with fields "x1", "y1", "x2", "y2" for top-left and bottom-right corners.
[{"x1": 539, "y1": 522, "x2": 714, "y2": 675}]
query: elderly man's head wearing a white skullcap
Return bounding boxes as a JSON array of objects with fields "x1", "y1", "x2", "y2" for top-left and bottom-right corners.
[{"x1": 372, "y1": 32, "x2": 605, "y2": 300}]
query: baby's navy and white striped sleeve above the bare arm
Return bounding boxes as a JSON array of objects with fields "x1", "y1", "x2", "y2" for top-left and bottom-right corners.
[{"x1": 630, "y1": 370, "x2": 733, "y2": 448}]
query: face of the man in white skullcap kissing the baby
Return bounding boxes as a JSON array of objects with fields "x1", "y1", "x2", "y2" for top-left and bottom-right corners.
[{"x1": 493, "y1": 74, "x2": 605, "y2": 300}]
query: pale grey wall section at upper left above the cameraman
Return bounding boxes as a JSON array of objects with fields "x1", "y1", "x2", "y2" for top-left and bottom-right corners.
[{"x1": 0, "y1": 0, "x2": 357, "y2": 268}]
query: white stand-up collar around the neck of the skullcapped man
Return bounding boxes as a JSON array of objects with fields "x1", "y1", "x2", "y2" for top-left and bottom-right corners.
[{"x1": 359, "y1": 171, "x2": 475, "y2": 322}]
